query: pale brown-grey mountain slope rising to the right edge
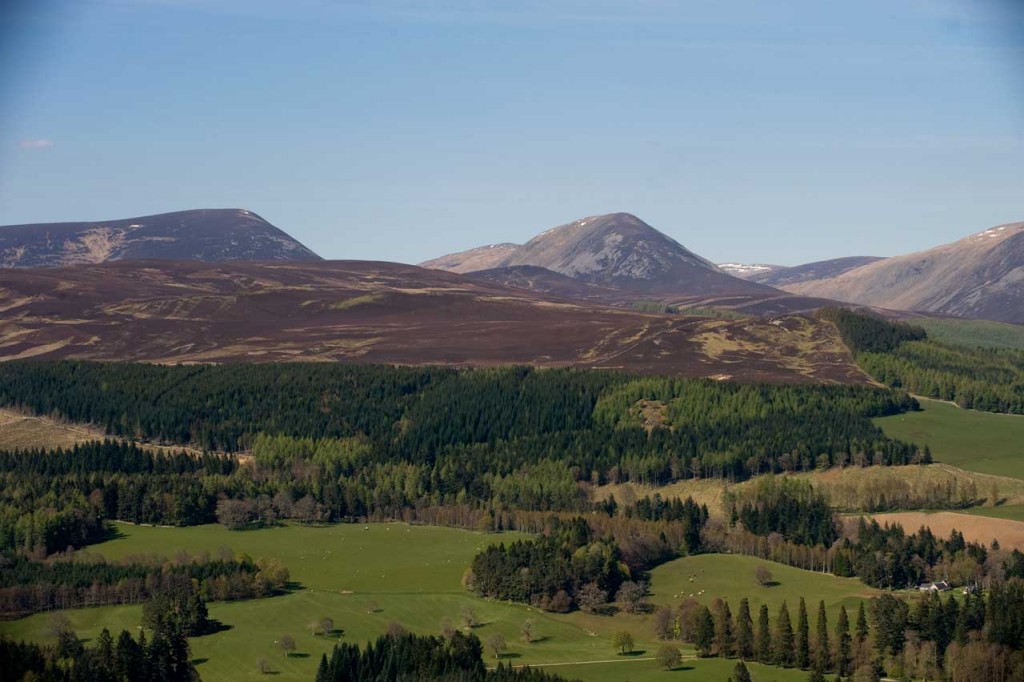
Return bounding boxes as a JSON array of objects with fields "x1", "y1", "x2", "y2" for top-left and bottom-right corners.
[{"x1": 782, "y1": 222, "x2": 1024, "y2": 325}]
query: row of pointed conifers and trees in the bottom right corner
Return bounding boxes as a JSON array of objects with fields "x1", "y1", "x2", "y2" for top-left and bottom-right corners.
[{"x1": 652, "y1": 578, "x2": 1024, "y2": 682}]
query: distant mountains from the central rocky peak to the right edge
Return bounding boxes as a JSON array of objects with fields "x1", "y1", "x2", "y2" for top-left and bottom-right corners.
[{"x1": 421, "y1": 213, "x2": 1024, "y2": 324}]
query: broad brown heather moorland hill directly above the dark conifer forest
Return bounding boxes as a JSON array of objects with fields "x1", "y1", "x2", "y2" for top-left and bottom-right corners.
[{"x1": 0, "y1": 260, "x2": 867, "y2": 383}]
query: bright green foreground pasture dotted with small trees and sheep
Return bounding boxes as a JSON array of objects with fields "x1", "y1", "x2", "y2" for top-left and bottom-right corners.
[{"x1": 0, "y1": 523, "x2": 847, "y2": 682}]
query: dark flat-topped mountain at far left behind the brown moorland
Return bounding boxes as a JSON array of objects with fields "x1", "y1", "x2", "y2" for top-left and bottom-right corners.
[{"x1": 0, "y1": 209, "x2": 321, "y2": 267}]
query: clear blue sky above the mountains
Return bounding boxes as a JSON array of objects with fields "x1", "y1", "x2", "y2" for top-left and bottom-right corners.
[{"x1": 0, "y1": 0, "x2": 1024, "y2": 264}]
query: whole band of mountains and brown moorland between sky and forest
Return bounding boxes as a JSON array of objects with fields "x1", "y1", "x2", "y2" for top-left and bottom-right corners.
[{"x1": 0, "y1": 204, "x2": 1024, "y2": 372}]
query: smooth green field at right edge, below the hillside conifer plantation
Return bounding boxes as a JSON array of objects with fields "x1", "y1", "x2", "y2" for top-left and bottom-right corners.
[{"x1": 874, "y1": 398, "x2": 1024, "y2": 479}]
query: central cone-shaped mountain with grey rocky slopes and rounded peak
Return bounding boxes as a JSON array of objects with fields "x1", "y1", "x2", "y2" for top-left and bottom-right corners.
[{"x1": 424, "y1": 213, "x2": 771, "y2": 295}]
